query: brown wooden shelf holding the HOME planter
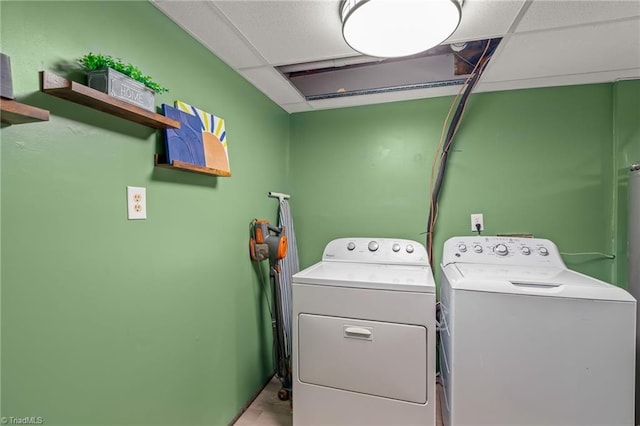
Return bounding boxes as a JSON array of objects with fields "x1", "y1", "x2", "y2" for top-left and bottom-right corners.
[{"x1": 40, "y1": 71, "x2": 180, "y2": 129}]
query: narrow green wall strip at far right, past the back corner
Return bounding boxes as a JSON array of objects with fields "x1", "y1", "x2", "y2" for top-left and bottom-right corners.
[{"x1": 613, "y1": 80, "x2": 640, "y2": 286}]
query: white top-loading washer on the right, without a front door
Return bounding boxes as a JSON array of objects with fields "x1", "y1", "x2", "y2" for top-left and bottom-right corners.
[{"x1": 439, "y1": 237, "x2": 636, "y2": 426}]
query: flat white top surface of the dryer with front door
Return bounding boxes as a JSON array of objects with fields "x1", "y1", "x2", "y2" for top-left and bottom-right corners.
[{"x1": 293, "y1": 262, "x2": 436, "y2": 293}]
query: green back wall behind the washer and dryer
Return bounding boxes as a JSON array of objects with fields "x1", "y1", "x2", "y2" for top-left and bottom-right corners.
[{"x1": 290, "y1": 84, "x2": 613, "y2": 279}]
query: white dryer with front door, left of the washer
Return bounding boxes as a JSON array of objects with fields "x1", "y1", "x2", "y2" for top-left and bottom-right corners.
[{"x1": 292, "y1": 238, "x2": 436, "y2": 426}]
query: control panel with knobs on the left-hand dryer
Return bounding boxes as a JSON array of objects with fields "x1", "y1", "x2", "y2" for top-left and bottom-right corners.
[{"x1": 322, "y1": 237, "x2": 429, "y2": 266}]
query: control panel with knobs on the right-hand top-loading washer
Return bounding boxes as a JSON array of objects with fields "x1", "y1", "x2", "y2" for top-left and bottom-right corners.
[{"x1": 442, "y1": 237, "x2": 565, "y2": 268}]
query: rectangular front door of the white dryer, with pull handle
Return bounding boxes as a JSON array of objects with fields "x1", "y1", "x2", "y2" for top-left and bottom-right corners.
[{"x1": 298, "y1": 314, "x2": 428, "y2": 404}]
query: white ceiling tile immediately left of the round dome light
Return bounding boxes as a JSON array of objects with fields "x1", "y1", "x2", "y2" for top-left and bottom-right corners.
[{"x1": 215, "y1": 0, "x2": 357, "y2": 65}]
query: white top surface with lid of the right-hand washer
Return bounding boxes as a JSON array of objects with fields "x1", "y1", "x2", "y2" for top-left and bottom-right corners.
[{"x1": 443, "y1": 263, "x2": 635, "y2": 302}]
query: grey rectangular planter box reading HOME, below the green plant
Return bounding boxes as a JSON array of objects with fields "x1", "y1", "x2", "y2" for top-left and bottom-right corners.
[{"x1": 87, "y1": 68, "x2": 156, "y2": 111}]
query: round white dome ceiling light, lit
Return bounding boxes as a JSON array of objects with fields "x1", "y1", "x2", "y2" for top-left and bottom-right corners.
[{"x1": 340, "y1": 0, "x2": 462, "y2": 58}]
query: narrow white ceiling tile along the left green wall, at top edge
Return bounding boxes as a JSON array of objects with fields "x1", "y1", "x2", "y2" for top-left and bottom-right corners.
[{"x1": 152, "y1": 0, "x2": 264, "y2": 68}]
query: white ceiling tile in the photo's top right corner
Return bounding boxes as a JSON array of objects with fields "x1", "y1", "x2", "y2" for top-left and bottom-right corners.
[{"x1": 516, "y1": 0, "x2": 640, "y2": 32}]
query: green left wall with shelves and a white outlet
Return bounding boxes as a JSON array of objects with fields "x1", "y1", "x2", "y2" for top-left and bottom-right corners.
[{"x1": 0, "y1": 1, "x2": 289, "y2": 425}]
